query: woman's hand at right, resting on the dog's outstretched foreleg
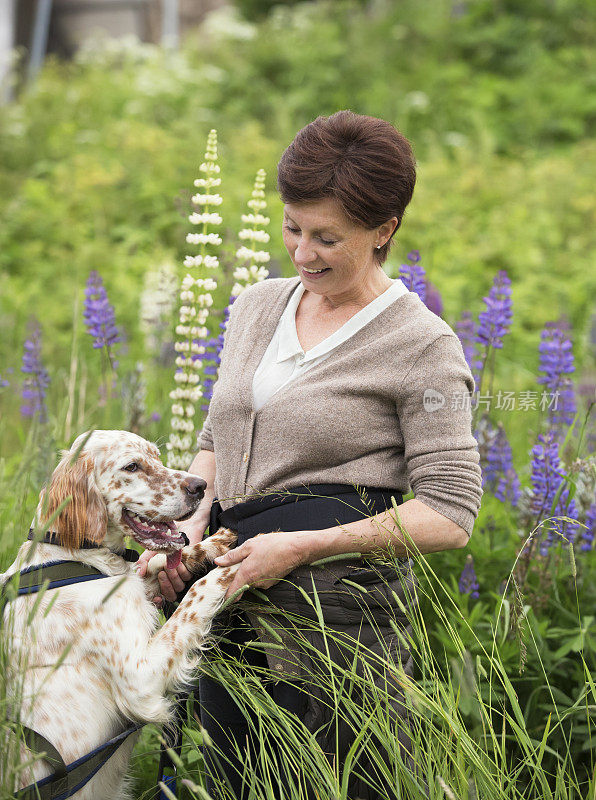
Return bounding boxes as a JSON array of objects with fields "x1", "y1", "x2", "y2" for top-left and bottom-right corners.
[{"x1": 215, "y1": 533, "x2": 307, "y2": 599}]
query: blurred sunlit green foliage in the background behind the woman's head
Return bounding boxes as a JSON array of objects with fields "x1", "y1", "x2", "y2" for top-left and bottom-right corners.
[{"x1": 0, "y1": 0, "x2": 596, "y2": 384}]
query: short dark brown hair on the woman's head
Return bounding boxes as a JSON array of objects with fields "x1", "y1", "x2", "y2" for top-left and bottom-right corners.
[{"x1": 277, "y1": 111, "x2": 416, "y2": 264}]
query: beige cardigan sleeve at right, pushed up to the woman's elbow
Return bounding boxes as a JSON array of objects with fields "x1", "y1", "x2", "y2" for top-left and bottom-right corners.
[{"x1": 397, "y1": 334, "x2": 482, "y2": 535}]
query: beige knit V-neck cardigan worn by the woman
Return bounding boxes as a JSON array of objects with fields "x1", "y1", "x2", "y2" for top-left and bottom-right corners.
[{"x1": 199, "y1": 278, "x2": 482, "y2": 534}]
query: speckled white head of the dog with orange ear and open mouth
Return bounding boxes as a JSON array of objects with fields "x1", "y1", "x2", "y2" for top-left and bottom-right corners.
[{"x1": 38, "y1": 430, "x2": 206, "y2": 566}]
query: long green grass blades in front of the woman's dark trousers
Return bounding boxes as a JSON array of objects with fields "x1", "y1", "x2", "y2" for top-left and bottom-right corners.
[{"x1": 140, "y1": 540, "x2": 596, "y2": 800}]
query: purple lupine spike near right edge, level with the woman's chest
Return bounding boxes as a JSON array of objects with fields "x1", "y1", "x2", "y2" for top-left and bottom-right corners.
[{"x1": 538, "y1": 320, "x2": 577, "y2": 432}]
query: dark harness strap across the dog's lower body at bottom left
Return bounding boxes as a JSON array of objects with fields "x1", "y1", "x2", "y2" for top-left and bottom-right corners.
[{"x1": 15, "y1": 723, "x2": 143, "y2": 800}]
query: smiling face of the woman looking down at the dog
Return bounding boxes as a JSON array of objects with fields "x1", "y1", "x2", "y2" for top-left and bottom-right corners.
[{"x1": 283, "y1": 198, "x2": 397, "y2": 302}]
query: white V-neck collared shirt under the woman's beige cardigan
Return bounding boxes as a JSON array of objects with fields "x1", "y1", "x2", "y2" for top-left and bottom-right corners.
[{"x1": 252, "y1": 278, "x2": 408, "y2": 411}]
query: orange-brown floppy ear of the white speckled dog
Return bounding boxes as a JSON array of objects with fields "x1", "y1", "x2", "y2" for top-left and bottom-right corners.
[{"x1": 40, "y1": 450, "x2": 108, "y2": 550}]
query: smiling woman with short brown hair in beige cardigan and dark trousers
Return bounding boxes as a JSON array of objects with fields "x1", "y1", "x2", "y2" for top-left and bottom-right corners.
[{"x1": 142, "y1": 111, "x2": 482, "y2": 798}]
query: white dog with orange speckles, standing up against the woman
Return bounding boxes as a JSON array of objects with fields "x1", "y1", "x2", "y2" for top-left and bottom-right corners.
[{"x1": 0, "y1": 430, "x2": 237, "y2": 800}]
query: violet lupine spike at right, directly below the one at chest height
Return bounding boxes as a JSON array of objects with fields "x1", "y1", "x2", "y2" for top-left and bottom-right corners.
[{"x1": 530, "y1": 430, "x2": 578, "y2": 555}]
